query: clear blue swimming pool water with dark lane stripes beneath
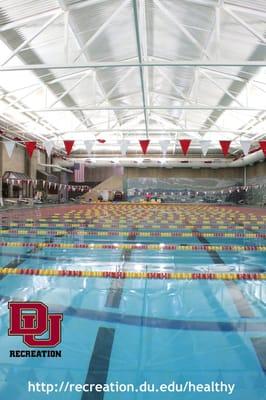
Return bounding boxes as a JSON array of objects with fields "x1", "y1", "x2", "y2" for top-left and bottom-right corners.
[{"x1": 0, "y1": 204, "x2": 266, "y2": 400}]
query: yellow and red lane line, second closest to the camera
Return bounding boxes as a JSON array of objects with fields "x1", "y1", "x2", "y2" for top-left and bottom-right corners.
[{"x1": 0, "y1": 242, "x2": 266, "y2": 252}]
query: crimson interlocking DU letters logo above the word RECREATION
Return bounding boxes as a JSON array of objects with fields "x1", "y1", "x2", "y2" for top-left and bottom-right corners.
[{"x1": 8, "y1": 301, "x2": 63, "y2": 347}]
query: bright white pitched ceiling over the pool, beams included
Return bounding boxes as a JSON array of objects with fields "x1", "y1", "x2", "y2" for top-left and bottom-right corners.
[{"x1": 0, "y1": 0, "x2": 266, "y2": 166}]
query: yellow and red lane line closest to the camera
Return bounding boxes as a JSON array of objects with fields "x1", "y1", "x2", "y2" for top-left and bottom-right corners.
[{"x1": 0, "y1": 268, "x2": 266, "y2": 280}]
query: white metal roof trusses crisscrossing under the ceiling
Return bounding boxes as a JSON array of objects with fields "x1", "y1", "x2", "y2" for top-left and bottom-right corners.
[{"x1": 0, "y1": 0, "x2": 266, "y2": 152}]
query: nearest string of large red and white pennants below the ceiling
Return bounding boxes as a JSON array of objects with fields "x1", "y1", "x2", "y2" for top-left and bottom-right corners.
[{"x1": 3, "y1": 139, "x2": 266, "y2": 158}]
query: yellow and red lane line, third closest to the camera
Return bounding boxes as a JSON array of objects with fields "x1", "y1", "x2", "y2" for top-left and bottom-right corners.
[{"x1": 0, "y1": 229, "x2": 266, "y2": 239}]
